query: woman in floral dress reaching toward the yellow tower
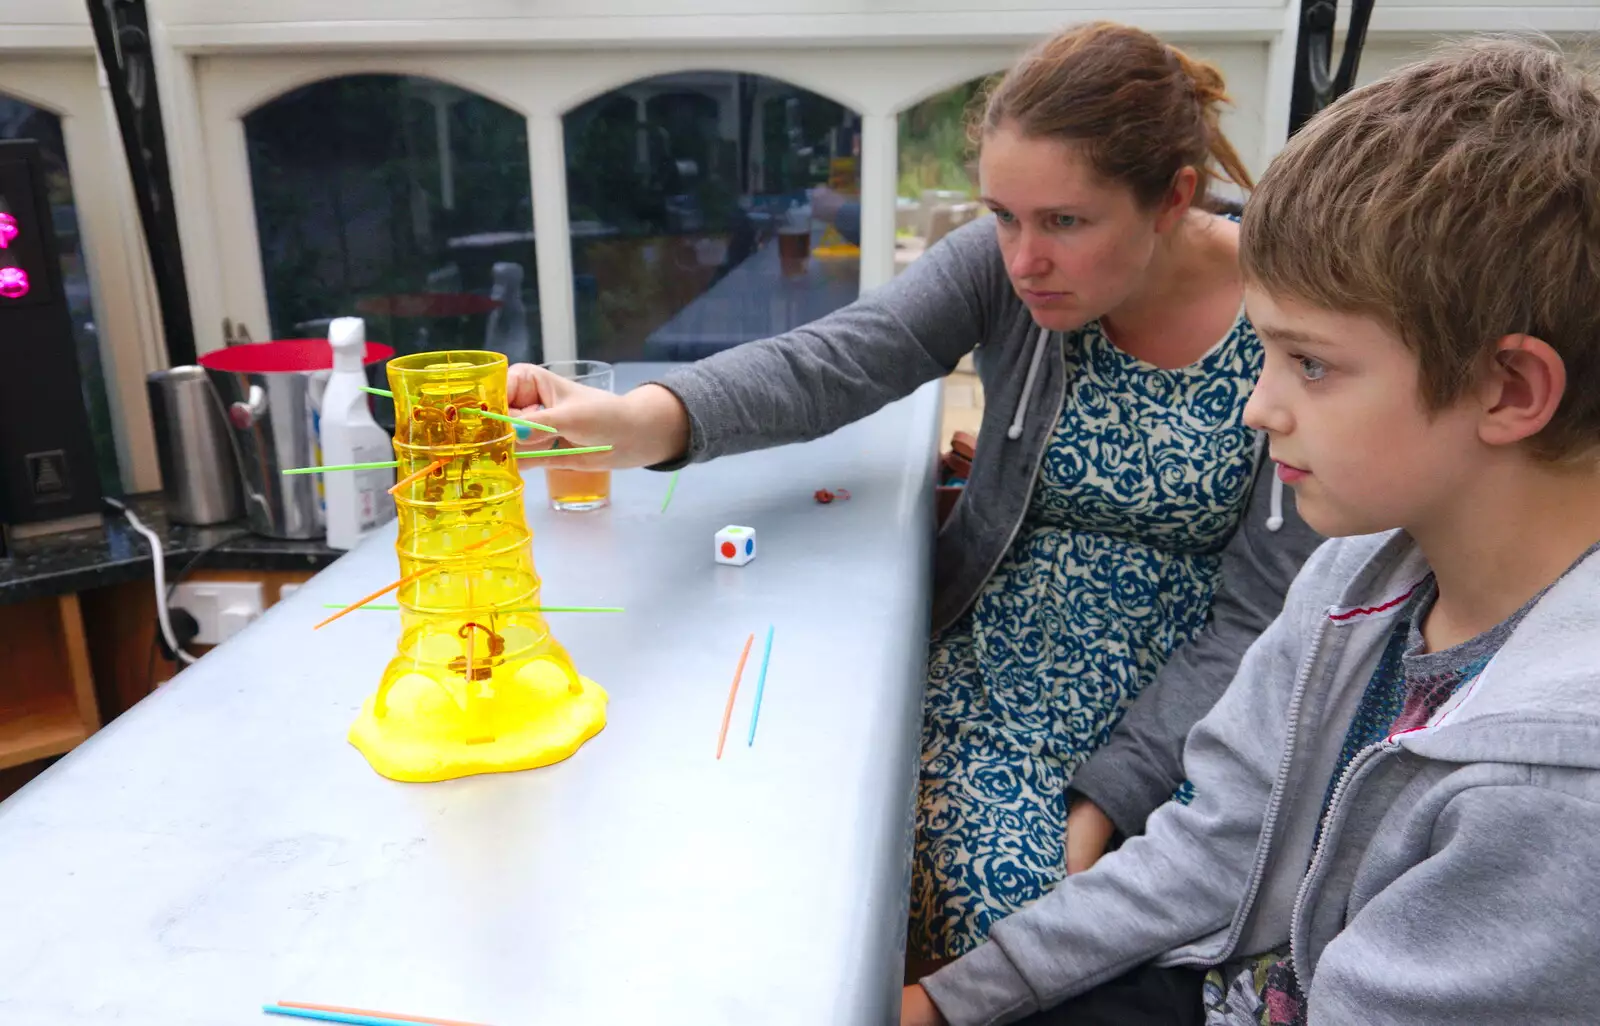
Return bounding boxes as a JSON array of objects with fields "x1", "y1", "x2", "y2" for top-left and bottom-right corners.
[{"x1": 512, "y1": 22, "x2": 1315, "y2": 964}]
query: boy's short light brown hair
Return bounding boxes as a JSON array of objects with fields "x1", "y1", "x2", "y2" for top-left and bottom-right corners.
[{"x1": 1240, "y1": 38, "x2": 1600, "y2": 459}]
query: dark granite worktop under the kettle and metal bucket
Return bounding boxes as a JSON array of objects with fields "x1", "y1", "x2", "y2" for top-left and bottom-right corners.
[{"x1": 0, "y1": 495, "x2": 344, "y2": 605}]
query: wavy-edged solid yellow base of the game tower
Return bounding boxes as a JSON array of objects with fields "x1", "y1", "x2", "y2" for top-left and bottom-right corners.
[{"x1": 350, "y1": 661, "x2": 606, "y2": 783}]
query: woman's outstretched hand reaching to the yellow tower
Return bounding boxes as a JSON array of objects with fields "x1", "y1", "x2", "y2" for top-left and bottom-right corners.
[{"x1": 506, "y1": 363, "x2": 690, "y2": 471}]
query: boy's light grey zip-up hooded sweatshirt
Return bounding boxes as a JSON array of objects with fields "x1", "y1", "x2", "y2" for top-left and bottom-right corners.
[{"x1": 923, "y1": 533, "x2": 1600, "y2": 1026}]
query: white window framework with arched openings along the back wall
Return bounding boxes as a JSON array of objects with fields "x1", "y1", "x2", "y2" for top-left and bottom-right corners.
[{"x1": 0, "y1": 0, "x2": 1600, "y2": 467}]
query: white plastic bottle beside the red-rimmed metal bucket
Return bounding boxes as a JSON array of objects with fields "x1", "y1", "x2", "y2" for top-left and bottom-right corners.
[{"x1": 318, "y1": 317, "x2": 395, "y2": 549}]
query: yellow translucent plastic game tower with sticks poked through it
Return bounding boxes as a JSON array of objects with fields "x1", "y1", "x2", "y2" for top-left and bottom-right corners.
[{"x1": 350, "y1": 352, "x2": 606, "y2": 781}]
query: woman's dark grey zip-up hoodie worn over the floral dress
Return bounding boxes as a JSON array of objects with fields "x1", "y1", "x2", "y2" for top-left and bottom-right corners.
[{"x1": 658, "y1": 218, "x2": 1322, "y2": 834}]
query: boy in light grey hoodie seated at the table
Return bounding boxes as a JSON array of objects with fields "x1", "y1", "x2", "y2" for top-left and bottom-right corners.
[{"x1": 902, "y1": 32, "x2": 1600, "y2": 1026}]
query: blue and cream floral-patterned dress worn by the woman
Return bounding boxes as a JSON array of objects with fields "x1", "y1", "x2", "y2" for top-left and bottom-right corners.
[{"x1": 910, "y1": 314, "x2": 1261, "y2": 957}]
